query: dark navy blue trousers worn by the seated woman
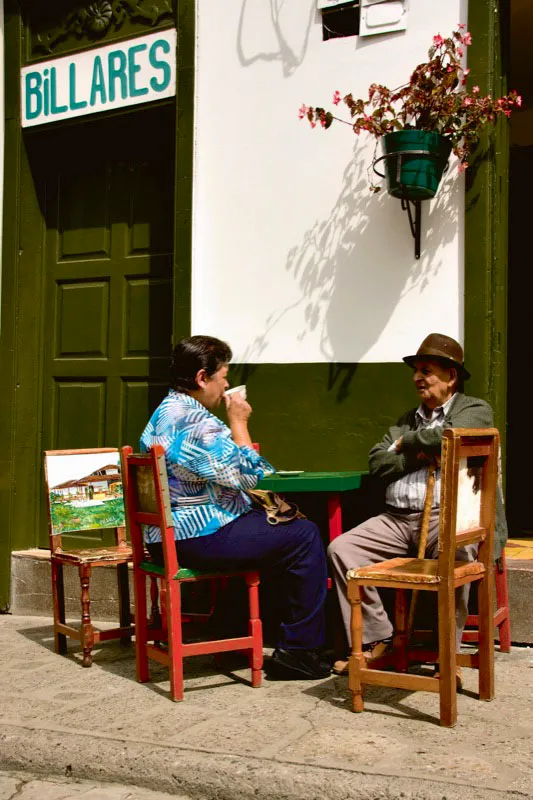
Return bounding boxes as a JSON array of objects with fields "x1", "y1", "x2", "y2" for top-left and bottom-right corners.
[{"x1": 148, "y1": 510, "x2": 327, "y2": 650}]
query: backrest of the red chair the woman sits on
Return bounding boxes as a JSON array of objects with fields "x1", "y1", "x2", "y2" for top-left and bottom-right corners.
[{"x1": 122, "y1": 444, "x2": 179, "y2": 580}]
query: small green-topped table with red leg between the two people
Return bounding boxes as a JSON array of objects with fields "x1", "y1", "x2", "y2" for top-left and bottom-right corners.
[{"x1": 257, "y1": 471, "x2": 368, "y2": 542}]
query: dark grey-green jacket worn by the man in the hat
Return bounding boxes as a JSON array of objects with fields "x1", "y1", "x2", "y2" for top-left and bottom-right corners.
[{"x1": 369, "y1": 392, "x2": 507, "y2": 558}]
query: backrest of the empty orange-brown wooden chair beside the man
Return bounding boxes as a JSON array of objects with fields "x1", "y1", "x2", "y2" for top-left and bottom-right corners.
[{"x1": 439, "y1": 428, "x2": 500, "y2": 577}]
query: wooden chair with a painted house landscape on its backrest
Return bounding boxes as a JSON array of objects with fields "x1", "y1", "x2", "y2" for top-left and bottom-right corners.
[{"x1": 44, "y1": 447, "x2": 134, "y2": 667}]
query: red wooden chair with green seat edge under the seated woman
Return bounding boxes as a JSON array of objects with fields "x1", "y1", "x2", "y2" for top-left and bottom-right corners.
[{"x1": 122, "y1": 445, "x2": 263, "y2": 701}]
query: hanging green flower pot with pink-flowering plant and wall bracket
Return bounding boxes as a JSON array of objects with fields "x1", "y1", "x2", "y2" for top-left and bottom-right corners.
[{"x1": 298, "y1": 24, "x2": 522, "y2": 253}]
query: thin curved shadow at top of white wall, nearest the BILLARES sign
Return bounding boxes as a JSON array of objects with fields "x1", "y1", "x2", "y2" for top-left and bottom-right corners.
[{"x1": 237, "y1": 0, "x2": 317, "y2": 77}]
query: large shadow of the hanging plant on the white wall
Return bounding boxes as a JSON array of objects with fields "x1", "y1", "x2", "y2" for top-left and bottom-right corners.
[{"x1": 239, "y1": 145, "x2": 458, "y2": 363}]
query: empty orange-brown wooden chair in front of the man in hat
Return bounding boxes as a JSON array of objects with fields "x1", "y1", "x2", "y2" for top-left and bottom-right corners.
[{"x1": 348, "y1": 428, "x2": 499, "y2": 727}]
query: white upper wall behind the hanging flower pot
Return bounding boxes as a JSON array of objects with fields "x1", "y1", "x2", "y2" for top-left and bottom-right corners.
[{"x1": 192, "y1": 0, "x2": 466, "y2": 363}]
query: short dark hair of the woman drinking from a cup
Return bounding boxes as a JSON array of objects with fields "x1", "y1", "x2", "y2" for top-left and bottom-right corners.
[{"x1": 170, "y1": 336, "x2": 233, "y2": 392}]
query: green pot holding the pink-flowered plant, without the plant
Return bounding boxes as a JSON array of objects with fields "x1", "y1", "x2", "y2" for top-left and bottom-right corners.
[{"x1": 380, "y1": 130, "x2": 452, "y2": 200}]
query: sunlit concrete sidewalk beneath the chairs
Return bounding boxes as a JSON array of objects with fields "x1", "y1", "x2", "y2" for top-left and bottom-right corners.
[{"x1": 0, "y1": 616, "x2": 533, "y2": 800}]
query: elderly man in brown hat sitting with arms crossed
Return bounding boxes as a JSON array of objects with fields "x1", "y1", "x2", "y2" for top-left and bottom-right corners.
[{"x1": 328, "y1": 333, "x2": 507, "y2": 683}]
